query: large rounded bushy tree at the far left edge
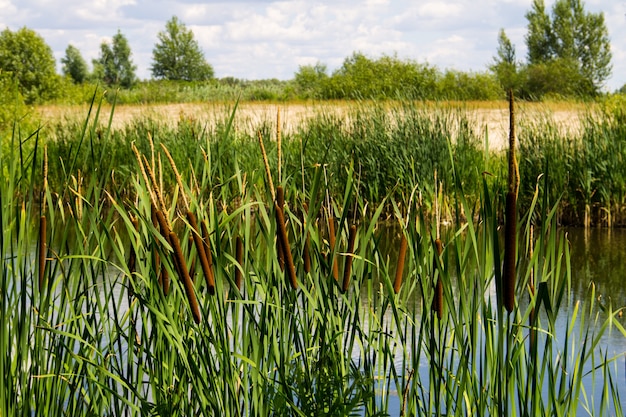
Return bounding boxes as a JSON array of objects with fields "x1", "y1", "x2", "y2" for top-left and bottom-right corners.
[{"x1": 0, "y1": 27, "x2": 60, "y2": 103}]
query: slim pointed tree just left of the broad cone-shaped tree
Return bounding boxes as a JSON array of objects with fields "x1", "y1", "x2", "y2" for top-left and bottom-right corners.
[{"x1": 93, "y1": 30, "x2": 137, "y2": 88}]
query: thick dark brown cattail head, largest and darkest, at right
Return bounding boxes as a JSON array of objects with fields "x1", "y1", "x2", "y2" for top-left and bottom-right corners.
[{"x1": 502, "y1": 192, "x2": 517, "y2": 313}]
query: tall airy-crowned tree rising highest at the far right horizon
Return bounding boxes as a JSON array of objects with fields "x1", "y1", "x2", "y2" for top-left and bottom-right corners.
[{"x1": 526, "y1": 0, "x2": 612, "y2": 95}]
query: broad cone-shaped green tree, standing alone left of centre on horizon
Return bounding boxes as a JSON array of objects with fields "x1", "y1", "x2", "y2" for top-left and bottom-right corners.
[{"x1": 151, "y1": 16, "x2": 213, "y2": 81}]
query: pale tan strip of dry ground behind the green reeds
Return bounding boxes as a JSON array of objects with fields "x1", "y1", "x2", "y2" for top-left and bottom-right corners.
[{"x1": 35, "y1": 100, "x2": 593, "y2": 150}]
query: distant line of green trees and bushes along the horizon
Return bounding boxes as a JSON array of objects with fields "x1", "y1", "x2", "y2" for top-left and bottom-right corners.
[{"x1": 0, "y1": 0, "x2": 626, "y2": 103}]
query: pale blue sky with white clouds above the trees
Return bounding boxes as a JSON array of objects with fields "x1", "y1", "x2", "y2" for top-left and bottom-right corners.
[{"x1": 0, "y1": 0, "x2": 626, "y2": 91}]
